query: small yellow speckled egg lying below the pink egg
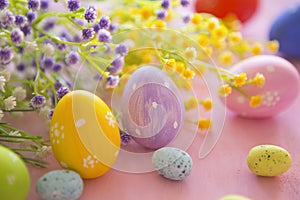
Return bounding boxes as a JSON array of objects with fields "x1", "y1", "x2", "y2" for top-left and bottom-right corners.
[{"x1": 247, "y1": 145, "x2": 292, "y2": 176}]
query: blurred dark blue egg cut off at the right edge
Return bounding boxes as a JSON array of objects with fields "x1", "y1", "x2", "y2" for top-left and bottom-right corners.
[{"x1": 269, "y1": 4, "x2": 300, "y2": 58}]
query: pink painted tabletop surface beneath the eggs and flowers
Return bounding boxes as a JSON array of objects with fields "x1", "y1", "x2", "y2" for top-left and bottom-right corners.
[{"x1": 19, "y1": 0, "x2": 300, "y2": 200}]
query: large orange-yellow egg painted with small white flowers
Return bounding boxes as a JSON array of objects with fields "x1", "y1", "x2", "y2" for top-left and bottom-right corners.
[{"x1": 50, "y1": 90, "x2": 120, "y2": 178}]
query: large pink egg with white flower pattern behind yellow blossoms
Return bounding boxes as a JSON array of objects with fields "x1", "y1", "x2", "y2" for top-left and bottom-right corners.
[{"x1": 223, "y1": 55, "x2": 300, "y2": 118}]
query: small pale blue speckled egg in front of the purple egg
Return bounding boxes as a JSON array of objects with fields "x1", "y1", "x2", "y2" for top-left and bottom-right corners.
[{"x1": 152, "y1": 147, "x2": 193, "y2": 180}]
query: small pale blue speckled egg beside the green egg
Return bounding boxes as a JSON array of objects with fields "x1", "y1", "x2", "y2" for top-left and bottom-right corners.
[{"x1": 36, "y1": 170, "x2": 83, "y2": 200}]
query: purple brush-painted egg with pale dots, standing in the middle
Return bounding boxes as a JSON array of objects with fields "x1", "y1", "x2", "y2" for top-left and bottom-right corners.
[{"x1": 121, "y1": 66, "x2": 184, "y2": 149}]
